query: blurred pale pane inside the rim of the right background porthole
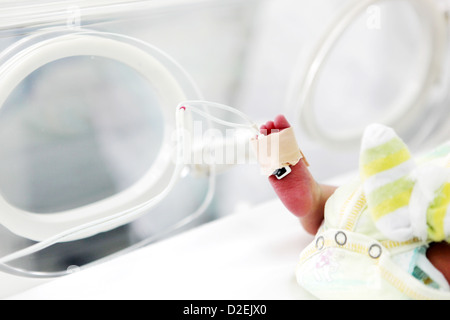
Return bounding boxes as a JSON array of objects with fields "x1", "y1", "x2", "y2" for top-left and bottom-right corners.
[{"x1": 313, "y1": 1, "x2": 431, "y2": 135}]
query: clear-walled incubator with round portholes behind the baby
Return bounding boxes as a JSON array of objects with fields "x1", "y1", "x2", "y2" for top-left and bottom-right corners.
[{"x1": 0, "y1": 0, "x2": 450, "y2": 298}]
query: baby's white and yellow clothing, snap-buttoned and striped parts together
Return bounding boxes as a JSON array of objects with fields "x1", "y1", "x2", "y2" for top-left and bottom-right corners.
[{"x1": 296, "y1": 125, "x2": 450, "y2": 300}]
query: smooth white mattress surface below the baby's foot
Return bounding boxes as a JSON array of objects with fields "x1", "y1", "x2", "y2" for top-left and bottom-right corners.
[{"x1": 7, "y1": 200, "x2": 313, "y2": 300}]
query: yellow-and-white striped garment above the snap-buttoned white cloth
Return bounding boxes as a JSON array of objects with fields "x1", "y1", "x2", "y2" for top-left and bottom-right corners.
[{"x1": 360, "y1": 125, "x2": 450, "y2": 242}]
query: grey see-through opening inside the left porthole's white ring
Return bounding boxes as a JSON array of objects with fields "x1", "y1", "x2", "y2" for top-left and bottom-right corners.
[{"x1": 0, "y1": 56, "x2": 164, "y2": 213}]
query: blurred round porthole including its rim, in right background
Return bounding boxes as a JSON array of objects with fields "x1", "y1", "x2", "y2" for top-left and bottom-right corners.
[{"x1": 290, "y1": 0, "x2": 446, "y2": 148}]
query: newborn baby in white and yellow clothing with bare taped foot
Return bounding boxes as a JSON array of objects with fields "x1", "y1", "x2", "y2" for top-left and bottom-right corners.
[{"x1": 261, "y1": 115, "x2": 450, "y2": 299}]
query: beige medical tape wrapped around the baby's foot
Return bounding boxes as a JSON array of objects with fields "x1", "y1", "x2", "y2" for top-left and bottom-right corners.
[{"x1": 251, "y1": 128, "x2": 309, "y2": 176}]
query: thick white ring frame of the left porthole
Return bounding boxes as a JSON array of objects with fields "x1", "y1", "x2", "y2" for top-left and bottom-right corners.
[{"x1": 0, "y1": 29, "x2": 204, "y2": 241}]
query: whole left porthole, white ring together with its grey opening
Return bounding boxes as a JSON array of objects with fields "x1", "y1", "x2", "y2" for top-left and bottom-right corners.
[{"x1": 0, "y1": 30, "x2": 201, "y2": 241}]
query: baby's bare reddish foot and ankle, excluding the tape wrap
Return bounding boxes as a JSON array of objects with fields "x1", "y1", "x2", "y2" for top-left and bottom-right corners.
[{"x1": 261, "y1": 115, "x2": 336, "y2": 234}]
